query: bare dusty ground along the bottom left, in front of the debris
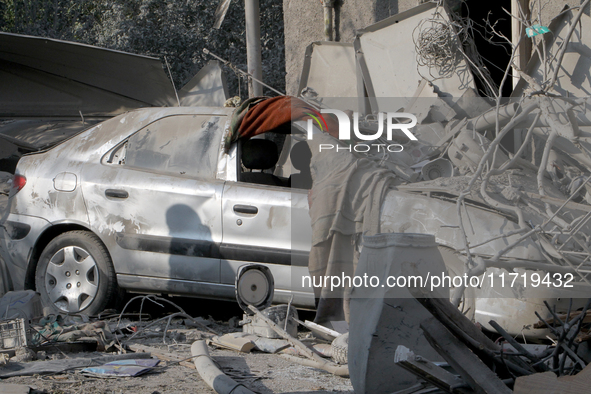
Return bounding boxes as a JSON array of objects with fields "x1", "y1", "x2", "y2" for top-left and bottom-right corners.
[{"x1": 0, "y1": 350, "x2": 353, "y2": 394}]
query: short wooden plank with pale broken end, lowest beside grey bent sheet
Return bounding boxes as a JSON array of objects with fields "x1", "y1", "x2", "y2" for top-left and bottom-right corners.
[{"x1": 394, "y1": 345, "x2": 474, "y2": 394}]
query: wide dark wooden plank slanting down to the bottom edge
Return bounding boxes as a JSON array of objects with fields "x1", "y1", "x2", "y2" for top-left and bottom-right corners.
[{"x1": 421, "y1": 318, "x2": 512, "y2": 394}]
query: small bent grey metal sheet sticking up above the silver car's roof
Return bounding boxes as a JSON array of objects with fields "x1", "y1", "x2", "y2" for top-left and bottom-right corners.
[{"x1": 179, "y1": 60, "x2": 230, "y2": 107}]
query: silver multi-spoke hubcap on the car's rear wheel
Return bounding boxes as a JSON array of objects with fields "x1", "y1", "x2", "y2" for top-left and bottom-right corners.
[{"x1": 45, "y1": 246, "x2": 99, "y2": 313}]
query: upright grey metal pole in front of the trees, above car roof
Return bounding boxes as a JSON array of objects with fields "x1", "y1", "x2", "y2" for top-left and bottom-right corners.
[{"x1": 244, "y1": 0, "x2": 263, "y2": 97}]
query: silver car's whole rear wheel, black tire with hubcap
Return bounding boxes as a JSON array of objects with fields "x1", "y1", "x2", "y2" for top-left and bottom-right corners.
[{"x1": 35, "y1": 231, "x2": 118, "y2": 315}]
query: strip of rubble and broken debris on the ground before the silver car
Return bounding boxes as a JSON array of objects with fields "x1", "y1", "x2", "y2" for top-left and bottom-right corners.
[{"x1": 0, "y1": 290, "x2": 350, "y2": 393}]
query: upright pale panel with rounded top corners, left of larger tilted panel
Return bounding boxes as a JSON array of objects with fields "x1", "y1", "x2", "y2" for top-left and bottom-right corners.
[{"x1": 298, "y1": 41, "x2": 357, "y2": 97}]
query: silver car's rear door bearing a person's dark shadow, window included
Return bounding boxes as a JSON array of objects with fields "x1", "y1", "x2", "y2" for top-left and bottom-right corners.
[{"x1": 82, "y1": 115, "x2": 225, "y2": 295}]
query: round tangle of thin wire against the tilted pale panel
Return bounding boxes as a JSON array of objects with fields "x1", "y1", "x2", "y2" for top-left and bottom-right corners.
[{"x1": 413, "y1": 19, "x2": 462, "y2": 79}]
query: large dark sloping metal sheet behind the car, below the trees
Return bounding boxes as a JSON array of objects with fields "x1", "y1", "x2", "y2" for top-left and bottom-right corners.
[{"x1": 0, "y1": 33, "x2": 176, "y2": 112}]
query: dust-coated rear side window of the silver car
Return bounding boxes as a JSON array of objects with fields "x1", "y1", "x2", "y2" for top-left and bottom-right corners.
[{"x1": 120, "y1": 115, "x2": 222, "y2": 178}]
